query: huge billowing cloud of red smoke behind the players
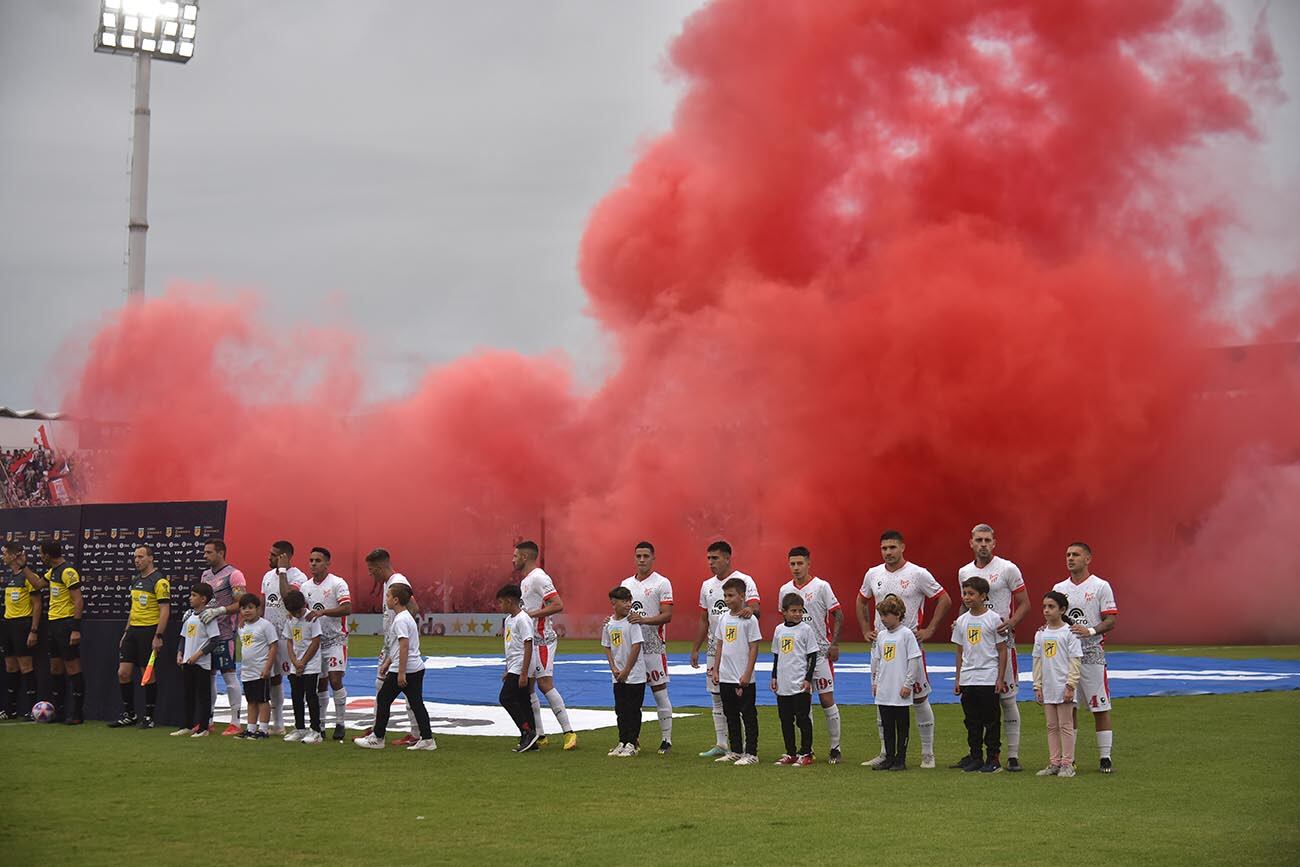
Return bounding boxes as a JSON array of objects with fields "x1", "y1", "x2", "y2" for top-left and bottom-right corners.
[{"x1": 66, "y1": 0, "x2": 1300, "y2": 642}]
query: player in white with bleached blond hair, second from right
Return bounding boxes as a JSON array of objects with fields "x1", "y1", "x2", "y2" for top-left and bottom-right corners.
[{"x1": 957, "y1": 524, "x2": 1030, "y2": 773}]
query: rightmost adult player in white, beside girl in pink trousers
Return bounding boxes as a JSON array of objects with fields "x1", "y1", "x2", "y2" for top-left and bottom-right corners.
[{"x1": 1052, "y1": 542, "x2": 1119, "y2": 773}]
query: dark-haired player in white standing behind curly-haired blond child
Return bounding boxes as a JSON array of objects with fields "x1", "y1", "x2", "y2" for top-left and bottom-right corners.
[{"x1": 857, "y1": 530, "x2": 953, "y2": 768}]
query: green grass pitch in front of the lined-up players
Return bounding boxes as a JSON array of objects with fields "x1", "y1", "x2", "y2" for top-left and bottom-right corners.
[{"x1": 0, "y1": 637, "x2": 1300, "y2": 866}]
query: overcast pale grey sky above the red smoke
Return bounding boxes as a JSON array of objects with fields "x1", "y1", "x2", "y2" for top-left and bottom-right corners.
[{"x1": 0, "y1": 0, "x2": 1300, "y2": 409}]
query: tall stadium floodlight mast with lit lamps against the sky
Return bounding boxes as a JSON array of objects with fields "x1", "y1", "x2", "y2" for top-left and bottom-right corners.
[{"x1": 95, "y1": 0, "x2": 199, "y2": 302}]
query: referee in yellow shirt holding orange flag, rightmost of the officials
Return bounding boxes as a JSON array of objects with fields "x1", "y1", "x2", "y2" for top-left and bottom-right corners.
[{"x1": 108, "y1": 545, "x2": 172, "y2": 728}]
